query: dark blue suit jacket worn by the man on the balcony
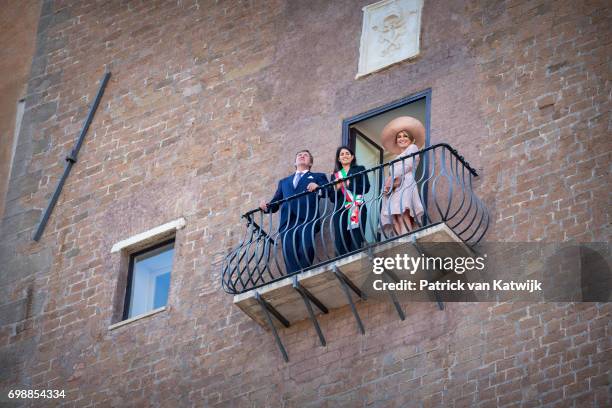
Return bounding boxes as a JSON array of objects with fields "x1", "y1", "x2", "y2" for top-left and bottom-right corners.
[{"x1": 269, "y1": 171, "x2": 328, "y2": 226}]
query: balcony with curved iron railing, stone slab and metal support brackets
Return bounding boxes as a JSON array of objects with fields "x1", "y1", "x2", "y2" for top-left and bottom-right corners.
[{"x1": 222, "y1": 144, "x2": 489, "y2": 360}]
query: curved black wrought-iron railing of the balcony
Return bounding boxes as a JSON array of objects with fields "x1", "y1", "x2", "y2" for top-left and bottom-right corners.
[{"x1": 222, "y1": 144, "x2": 489, "y2": 294}]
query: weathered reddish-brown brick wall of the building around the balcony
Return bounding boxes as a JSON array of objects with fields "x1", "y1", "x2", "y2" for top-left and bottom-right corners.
[{"x1": 0, "y1": 0, "x2": 612, "y2": 407}]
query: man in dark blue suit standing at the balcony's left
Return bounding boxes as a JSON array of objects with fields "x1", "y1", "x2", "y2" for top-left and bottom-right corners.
[{"x1": 259, "y1": 150, "x2": 327, "y2": 274}]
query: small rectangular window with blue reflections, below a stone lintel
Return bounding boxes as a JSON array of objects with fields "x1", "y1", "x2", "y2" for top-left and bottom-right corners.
[{"x1": 123, "y1": 239, "x2": 174, "y2": 320}]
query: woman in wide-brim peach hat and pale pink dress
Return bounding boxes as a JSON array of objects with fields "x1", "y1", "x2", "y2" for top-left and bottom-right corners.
[{"x1": 380, "y1": 116, "x2": 425, "y2": 235}]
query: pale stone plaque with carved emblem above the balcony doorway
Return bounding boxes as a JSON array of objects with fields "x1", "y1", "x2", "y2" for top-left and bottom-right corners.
[{"x1": 357, "y1": 0, "x2": 423, "y2": 78}]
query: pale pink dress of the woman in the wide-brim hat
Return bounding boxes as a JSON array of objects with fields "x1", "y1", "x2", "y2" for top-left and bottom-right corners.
[{"x1": 380, "y1": 144, "x2": 423, "y2": 226}]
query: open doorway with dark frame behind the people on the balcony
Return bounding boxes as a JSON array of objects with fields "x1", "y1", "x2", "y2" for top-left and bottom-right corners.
[{"x1": 342, "y1": 89, "x2": 431, "y2": 242}]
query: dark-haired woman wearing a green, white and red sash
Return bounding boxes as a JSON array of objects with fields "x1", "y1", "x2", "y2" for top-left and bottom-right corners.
[{"x1": 329, "y1": 146, "x2": 370, "y2": 256}]
